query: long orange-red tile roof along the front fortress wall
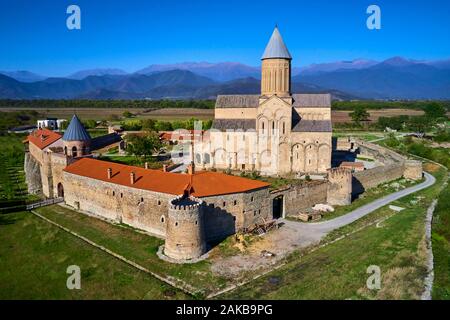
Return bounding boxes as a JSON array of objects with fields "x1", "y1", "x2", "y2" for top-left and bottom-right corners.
[{"x1": 64, "y1": 158, "x2": 269, "y2": 197}]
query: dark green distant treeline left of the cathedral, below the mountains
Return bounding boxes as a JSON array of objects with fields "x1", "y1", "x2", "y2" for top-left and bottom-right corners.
[{"x1": 0, "y1": 99, "x2": 215, "y2": 109}]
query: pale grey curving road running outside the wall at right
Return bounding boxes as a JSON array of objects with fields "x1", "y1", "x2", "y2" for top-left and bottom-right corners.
[{"x1": 283, "y1": 172, "x2": 436, "y2": 239}]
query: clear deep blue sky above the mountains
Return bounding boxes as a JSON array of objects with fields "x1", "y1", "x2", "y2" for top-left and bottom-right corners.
[{"x1": 0, "y1": 0, "x2": 450, "y2": 76}]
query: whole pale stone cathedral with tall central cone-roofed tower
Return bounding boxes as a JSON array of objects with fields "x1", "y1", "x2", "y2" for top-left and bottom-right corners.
[{"x1": 195, "y1": 28, "x2": 332, "y2": 175}]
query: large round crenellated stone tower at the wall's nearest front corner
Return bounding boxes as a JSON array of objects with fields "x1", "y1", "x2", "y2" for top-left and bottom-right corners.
[{"x1": 164, "y1": 196, "x2": 206, "y2": 260}]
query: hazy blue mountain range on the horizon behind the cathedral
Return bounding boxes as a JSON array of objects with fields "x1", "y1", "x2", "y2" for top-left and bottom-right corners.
[{"x1": 0, "y1": 57, "x2": 450, "y2": 99}]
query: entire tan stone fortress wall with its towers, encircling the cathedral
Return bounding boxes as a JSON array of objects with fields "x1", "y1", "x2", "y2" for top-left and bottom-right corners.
[{"x1": 24, "y1": 129, "x2": 422, "y2": 260}]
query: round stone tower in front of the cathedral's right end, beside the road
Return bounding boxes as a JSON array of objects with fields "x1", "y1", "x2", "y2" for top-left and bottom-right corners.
[{"x1": 327, "y1": 168, "x2": 353, "y2": 206}]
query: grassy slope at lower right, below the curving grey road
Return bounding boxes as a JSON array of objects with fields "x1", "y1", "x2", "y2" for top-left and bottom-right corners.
[{"x1": 219, "y1": 165, "x2": 445, "y2": 299}]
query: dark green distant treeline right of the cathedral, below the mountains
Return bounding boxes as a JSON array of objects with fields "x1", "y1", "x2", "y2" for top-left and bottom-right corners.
[{"x1": 332, "y1": 100, "x2": 450, "y2": 111}]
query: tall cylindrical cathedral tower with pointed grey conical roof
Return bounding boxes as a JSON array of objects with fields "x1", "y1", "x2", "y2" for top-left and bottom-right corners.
[{"x1": 261, "y1": 26, "x2": 292, "y2": 97}]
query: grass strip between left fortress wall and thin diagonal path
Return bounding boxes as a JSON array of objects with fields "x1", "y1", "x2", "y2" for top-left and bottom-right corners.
[{"x1": 36, "y1": 205, "x2": 228, "y2": 296}]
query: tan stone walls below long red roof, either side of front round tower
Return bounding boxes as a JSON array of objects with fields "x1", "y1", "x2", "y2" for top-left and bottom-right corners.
[{"x1": 64, "y1": 172, "x2": 271, "y2": 241}]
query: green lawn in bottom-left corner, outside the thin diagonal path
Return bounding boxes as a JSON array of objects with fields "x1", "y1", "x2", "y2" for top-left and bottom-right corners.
[{"x1": 0, "y1": 212, "x2": 189, "y2": 299}]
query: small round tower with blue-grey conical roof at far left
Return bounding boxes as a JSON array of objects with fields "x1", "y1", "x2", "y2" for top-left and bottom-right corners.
[{"x1": 62, "y1": 115, "x2": 91, "y2": 158}]
